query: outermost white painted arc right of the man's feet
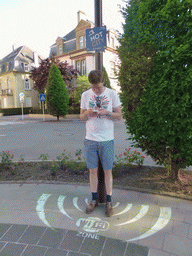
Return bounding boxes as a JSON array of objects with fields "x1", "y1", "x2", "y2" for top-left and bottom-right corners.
[{"x1": 127, "y1": 207, "x2": 171, "y2": 242}]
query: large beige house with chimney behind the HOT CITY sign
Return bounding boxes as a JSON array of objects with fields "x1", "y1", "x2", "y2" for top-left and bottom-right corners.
[{"x1": 49, "y1": 11, "x2": 120, "y2": 91}]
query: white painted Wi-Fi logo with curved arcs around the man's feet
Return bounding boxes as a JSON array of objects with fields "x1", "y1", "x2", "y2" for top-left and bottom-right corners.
[{"x1": 36, "y1": 193, "x2": 172, "y2": 241}]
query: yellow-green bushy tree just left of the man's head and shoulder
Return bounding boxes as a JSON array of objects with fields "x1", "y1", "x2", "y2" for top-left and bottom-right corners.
[{"x1": 69, "y1": 75, "x2": 91, "y2": 114}]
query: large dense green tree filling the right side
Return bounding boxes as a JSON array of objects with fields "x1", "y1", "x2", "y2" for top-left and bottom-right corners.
[{"x1": 119, "y1": 0, "x2": 192, "y2": 180}]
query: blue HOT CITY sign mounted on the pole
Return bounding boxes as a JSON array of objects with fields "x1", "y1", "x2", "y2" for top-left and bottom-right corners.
[{"x1": 86, "y1": 26, "x2": 107, "y2": 52}]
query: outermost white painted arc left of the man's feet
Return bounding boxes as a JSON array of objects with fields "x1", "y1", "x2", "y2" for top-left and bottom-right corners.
[{"x1": 36, "y1": 193, "x2": 52, "y2": 228}]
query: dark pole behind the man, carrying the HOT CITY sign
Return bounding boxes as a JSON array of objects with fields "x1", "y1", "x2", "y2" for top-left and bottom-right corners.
[{"x1": 95, "y1": 0, "x2": 106, "y2": 203}]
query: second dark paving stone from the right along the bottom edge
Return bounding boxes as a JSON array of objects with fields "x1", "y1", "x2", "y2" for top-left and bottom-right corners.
[{"x1": 102, "y1": 238, "x2": 127, "y2": 256}]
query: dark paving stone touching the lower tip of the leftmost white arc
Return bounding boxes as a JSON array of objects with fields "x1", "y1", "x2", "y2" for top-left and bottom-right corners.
[{"x1": 38, "y1": 228, "x2": 66, "y2": 248}]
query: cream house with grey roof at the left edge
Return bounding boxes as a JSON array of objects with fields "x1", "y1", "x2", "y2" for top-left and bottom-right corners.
[{"x1": 0, "y1": 46, "x2": 41, "y2": 108}]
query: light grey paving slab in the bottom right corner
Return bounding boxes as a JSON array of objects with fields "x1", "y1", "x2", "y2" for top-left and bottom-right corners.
[{"x1": 163, "y1": 234, "x2": 192, "y2": 256}]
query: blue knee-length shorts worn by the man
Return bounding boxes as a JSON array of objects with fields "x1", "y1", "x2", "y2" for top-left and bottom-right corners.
[{"x1": 84, "y1": 139, "x2": 114, "y2": 170}]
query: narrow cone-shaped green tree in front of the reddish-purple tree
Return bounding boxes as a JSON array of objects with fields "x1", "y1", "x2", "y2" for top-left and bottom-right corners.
[{"x1": 46, "y1": 63, "x2": 69, "y2": 121}]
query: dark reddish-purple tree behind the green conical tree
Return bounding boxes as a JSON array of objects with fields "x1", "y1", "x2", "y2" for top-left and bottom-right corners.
[{"x1": 30, "y1": 58, "x2": 77, "y2": 93}]
